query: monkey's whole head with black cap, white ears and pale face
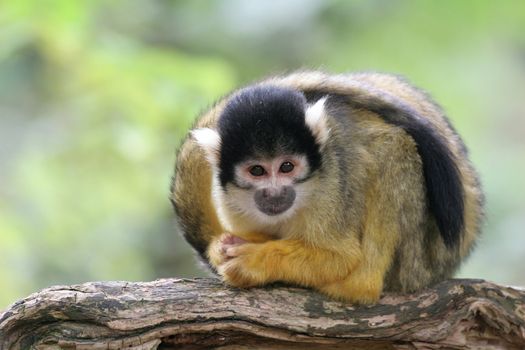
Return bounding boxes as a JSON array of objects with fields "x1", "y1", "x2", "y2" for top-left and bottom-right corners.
[{"x1": 192, "y1": 85, "x2": 329, "y2": 223}]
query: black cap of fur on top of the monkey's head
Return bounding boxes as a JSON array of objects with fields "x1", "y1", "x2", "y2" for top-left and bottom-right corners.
[{"x1": 218, "y1": 85, "x2": 321, "y2": 187}]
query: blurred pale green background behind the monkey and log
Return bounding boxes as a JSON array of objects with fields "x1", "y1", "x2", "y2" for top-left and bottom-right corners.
[{"x1": 0, "y1": 0, "x2": 525, "y2": 309}]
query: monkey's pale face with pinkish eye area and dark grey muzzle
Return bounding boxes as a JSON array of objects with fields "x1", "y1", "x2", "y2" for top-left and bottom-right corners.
[{"x1": 225, "y1": 155, "x2": 309, "y2": 219}]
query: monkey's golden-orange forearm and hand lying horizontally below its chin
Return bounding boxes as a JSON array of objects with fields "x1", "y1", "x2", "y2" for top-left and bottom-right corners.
[{"x1": 218, "y1": 239, "x2": 362, "y2": 289}]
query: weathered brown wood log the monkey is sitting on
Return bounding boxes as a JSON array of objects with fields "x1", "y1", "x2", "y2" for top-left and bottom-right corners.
[{"x1": 0, "y1": 279, "x2": 525, "y2": 350}]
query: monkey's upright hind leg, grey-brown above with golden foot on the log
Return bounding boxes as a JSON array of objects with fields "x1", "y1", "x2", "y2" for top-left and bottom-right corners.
[{"x1": 320, "y1": 134, "x2": 426, "y2": 303}]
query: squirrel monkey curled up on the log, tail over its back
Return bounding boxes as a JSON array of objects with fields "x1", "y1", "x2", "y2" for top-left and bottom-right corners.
[{"x1": 171, "y1": 72, "x2": 483, "y2": 303}]
